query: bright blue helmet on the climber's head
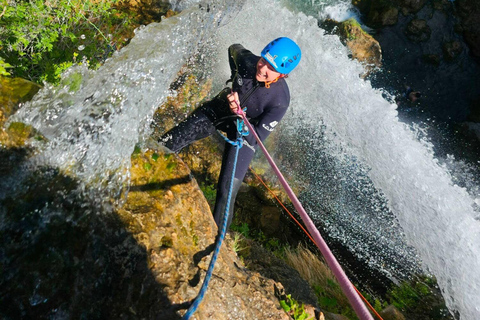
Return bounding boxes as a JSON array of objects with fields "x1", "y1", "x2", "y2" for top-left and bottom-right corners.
[{"x1": 261, "y1": 37, "x2": 302, "y2": 74}]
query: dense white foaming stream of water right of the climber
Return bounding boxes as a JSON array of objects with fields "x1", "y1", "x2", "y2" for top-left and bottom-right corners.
[{"x1": 211, "y1": 1, "x2": 480, "y2": 319}]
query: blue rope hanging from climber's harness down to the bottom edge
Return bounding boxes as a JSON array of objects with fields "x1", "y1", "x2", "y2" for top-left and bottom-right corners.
[{"x1": 182, "y1": 120, "x2": 248, "y2": 320}]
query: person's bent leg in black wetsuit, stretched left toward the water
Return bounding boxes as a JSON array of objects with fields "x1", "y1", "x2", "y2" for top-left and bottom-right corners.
[{"x1": 159, "y1": 107, "x2": 215, "y2": 152}]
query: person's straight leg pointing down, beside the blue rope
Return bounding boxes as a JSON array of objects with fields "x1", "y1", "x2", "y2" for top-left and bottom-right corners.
[{"x1": 213, "y1": 144, "x2": 255, "y2": 229}]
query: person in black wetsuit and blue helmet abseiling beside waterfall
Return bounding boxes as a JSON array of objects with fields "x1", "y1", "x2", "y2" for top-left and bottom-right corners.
[{"x1": 159, "y1": 37, "x2": 301, "y2": 228}]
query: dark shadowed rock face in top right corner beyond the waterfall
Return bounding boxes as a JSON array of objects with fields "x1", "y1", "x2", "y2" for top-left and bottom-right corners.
[{"x1": 353, "y1": 0, "x2": 480, "y2": 123}]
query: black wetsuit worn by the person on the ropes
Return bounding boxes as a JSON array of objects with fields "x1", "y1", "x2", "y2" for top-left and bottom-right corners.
[{"x1": 160, "y1": 44, "x2": 290, "y2": 225}]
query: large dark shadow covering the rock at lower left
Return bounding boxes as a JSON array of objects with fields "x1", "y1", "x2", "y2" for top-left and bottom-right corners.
[{"x1": 0, "y1": 161, "x2": 180, "y2": 319}]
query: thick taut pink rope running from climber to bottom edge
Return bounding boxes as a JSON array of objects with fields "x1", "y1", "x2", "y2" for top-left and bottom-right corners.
[{"x1": 232, "y1": 103, "x2": 373, "y2": 320}]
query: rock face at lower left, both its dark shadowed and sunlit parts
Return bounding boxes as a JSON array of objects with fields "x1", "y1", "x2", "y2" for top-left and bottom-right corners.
[{"x1": 0, "y1": 142, "x2": 308, "y2": 319}]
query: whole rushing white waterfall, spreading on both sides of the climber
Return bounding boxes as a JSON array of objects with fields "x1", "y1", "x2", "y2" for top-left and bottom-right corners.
[{"x1": 11, "y1": 0, "x2": 480, "y2": 320}]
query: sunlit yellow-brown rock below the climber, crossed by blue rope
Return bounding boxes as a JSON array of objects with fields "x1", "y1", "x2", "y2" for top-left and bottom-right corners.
[{"x1": 119, "y1": 151, "x2": 294, "y2": 319}]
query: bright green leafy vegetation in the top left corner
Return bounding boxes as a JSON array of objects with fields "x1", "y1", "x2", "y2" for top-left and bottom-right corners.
[{"x1": 0, "y1": 0, "x2": 172, "y2": 83}]
